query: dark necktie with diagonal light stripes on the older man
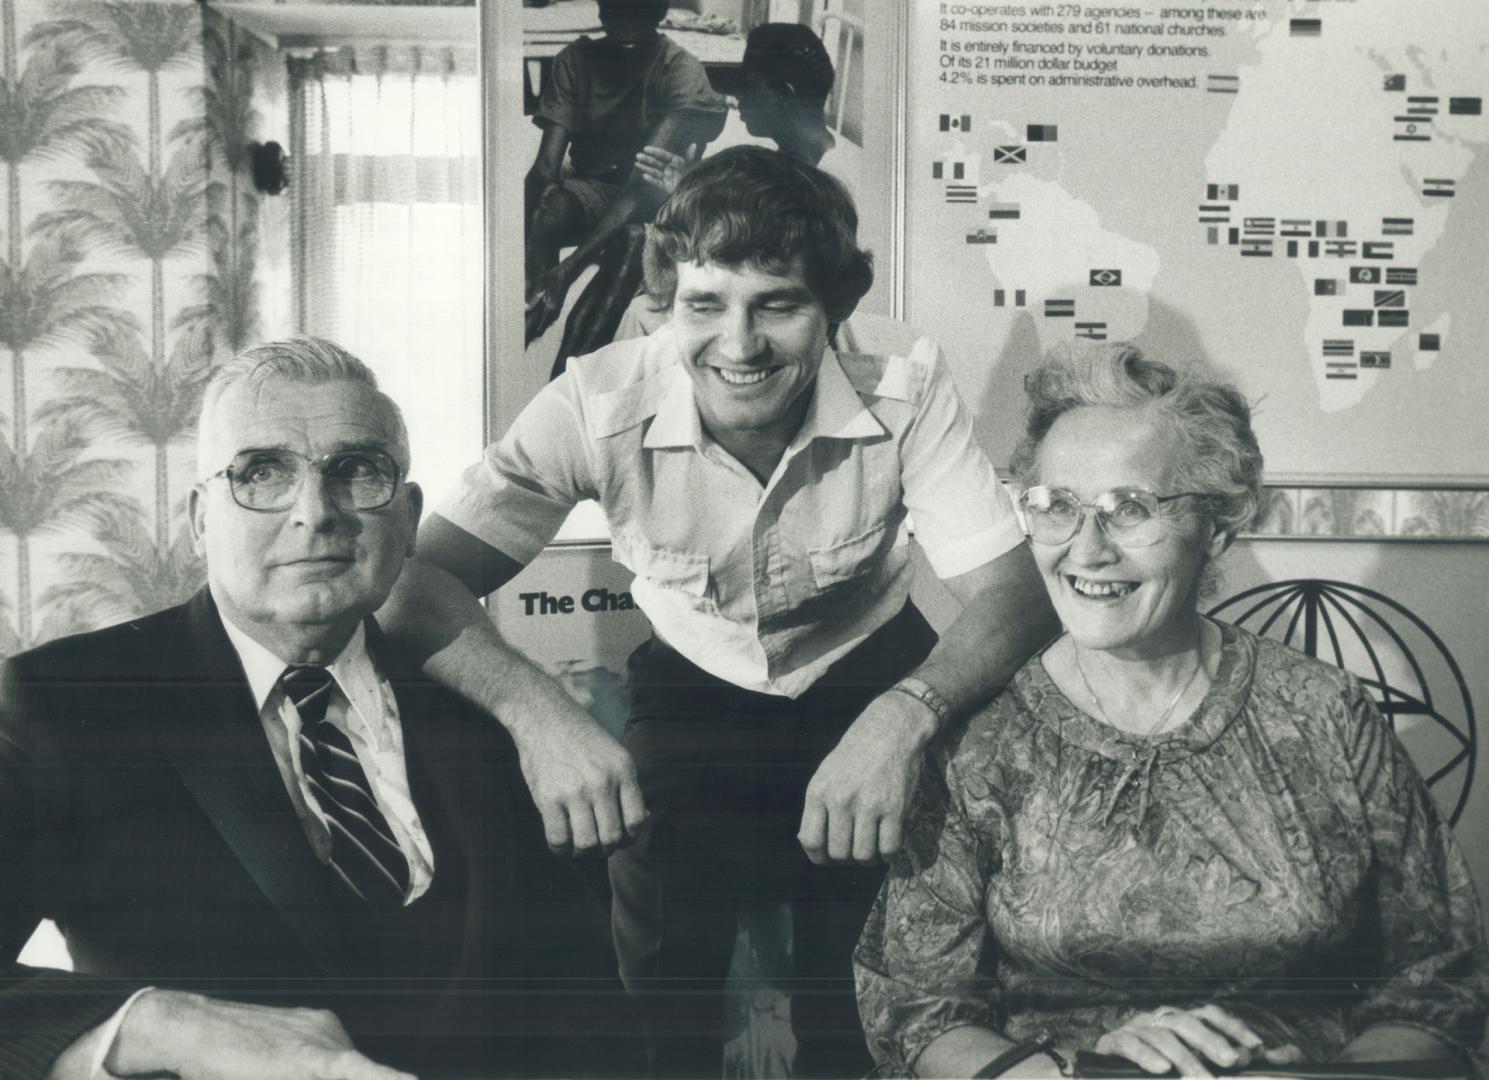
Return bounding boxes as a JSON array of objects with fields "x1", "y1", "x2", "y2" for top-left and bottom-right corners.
[{"x1": 280, "y1": 666, "x2": 408, "y2": 910}]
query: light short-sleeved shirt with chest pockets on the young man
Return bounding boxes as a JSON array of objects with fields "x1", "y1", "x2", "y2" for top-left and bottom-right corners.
[{"x1": 439, "y1": 326, "x2": 1023, "y2": 697}]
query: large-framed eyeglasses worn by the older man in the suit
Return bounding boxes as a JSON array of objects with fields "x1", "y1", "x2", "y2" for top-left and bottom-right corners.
[{"x1": 207, "y1": 448, "x2": 399, "y2": 512}]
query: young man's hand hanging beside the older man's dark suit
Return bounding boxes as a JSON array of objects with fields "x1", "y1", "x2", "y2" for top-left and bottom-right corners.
[{"x1": 509, "y1": 697, "x2": 646, "y2": 855}]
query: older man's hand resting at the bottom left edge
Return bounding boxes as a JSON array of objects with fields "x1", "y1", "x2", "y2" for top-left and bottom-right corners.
[{"x1": 104, "y1": 991, "x2": 415, "y2": 1080}]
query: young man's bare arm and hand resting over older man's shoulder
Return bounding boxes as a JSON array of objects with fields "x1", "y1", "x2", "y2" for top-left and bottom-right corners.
[{"x1": 378, "y1": 514, "x2": 646, "y2": 854}]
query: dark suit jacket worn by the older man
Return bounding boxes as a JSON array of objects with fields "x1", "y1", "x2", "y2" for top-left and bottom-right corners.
[{"x1": 0, "y1": 590, "x2": 631, "y2": 1077}]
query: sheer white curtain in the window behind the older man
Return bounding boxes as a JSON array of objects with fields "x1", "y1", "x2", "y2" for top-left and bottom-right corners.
[{"x1": 290, "y1": 45, "x2": 484, "y2": 499}]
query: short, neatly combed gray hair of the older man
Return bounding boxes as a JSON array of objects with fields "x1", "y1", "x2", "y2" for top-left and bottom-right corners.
[{"x1": 197, "y1": 334, "x2": 409, "y2": 477}]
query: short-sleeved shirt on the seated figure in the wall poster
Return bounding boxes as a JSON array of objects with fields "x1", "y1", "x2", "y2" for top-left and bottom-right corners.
[{"x1": 533, "y1": 37, "x2": 727, "y2": 183}]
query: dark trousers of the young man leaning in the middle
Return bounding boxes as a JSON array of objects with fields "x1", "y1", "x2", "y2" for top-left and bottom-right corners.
[{"x1": 609, "y1": 603, "x2": 935, "y2": 1077}]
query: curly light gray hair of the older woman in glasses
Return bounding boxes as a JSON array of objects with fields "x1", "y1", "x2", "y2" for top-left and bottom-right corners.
[{"x1": 1013, "y1": 341, "x2": 1261, "y2": 536}]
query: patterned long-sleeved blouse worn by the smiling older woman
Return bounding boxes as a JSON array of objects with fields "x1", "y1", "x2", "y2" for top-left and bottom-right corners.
[{"x1": 855, "y1": 624, "x2": 1489, "y2": 1076}]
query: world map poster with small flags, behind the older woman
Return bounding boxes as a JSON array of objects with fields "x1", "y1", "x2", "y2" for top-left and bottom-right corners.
[{"x1": 905, "y1": 0, "x2": 1489, "y2": 483}]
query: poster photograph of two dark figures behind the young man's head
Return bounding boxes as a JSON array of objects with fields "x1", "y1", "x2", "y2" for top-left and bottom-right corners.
[{"x1": 518, "y1": 0, "x2": 895, "y2": 396}]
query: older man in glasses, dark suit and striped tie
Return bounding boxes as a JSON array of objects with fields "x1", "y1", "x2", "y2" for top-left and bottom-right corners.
[{"x1": 0, "y1": 338, "x2": 624, "y2": 1080}]
